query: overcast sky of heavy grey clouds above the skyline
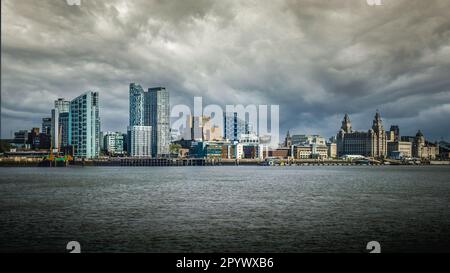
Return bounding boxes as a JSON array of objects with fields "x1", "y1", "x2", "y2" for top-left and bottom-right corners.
[{"x1": 1, "y1": 0, "x2": 450, "y2": 140}]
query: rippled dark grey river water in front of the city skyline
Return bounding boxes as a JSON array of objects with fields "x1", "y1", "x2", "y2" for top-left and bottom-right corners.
[{"x1": 0, "y1": 166, "x2": 450, "y2": 252}]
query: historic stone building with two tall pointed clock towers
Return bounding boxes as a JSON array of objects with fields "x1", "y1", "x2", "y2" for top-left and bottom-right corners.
[{"x1": 337, "y1": 111, "x2": 387, "y2": 158}]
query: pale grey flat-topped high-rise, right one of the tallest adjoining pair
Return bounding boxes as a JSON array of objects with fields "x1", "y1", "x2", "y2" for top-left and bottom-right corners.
[{"x1": 148, "y1": 87, "x2": 170, "y2": 157}]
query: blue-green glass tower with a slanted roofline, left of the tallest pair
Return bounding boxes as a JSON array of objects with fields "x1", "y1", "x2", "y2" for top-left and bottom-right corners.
[{"x1": 70, "y1": 91, "x2": 100, "y2": 158}]
